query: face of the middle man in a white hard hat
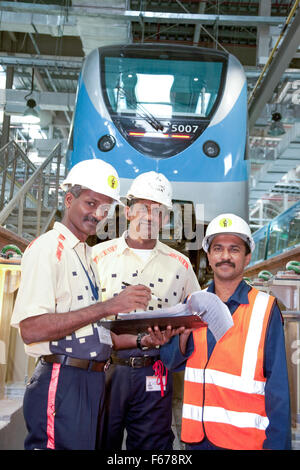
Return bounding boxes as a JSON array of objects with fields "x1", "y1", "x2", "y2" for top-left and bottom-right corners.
[{"x1": 126, "y1": 199, "x2": 168, "y2": 240}]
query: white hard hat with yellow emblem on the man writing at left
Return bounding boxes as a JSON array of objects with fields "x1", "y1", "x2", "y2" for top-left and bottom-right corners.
[{"x1": 60, "y1": 158, "x2": 124, "y2": 205}]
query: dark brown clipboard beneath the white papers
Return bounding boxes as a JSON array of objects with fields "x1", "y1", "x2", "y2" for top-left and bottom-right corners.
[{"x1": 97, "y1": 314, "x2": 207, "y2": 335}]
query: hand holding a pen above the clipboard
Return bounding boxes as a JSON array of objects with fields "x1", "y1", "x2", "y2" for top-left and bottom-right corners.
[{"x1": 106, "y1": 284, "x2": 151, "y2": 315}]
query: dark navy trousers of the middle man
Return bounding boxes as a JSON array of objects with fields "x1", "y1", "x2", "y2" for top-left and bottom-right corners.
[{"x1": 100, "y1": 365, "x2": 174, "y2": 451}]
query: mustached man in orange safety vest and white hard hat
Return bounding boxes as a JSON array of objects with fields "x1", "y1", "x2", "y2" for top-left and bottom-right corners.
[{"x1": 161, "y1": 213, "x2": 291, "y2": 450}]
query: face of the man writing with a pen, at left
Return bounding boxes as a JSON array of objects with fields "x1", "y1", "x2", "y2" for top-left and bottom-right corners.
[{"x1": 64, "y1": 189, "x2": 114, "y2": 241}]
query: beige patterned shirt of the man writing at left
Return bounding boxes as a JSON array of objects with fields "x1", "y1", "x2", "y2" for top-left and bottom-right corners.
[{"x1": 11, "y1": 222, "x2": 111, "y2": 360}]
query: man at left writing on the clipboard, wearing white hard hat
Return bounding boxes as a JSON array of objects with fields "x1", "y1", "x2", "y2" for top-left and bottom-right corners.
[{"x1": 11, "y1": 159, "x2": 158, "y2": 450}]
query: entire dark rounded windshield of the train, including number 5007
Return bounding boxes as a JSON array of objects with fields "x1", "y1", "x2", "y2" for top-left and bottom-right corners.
[{"x1": 101, "y1": 51, "x2": 227, "y2": 157}]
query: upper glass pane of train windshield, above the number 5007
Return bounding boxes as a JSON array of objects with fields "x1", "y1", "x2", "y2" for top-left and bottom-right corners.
[{"x1": 105, "y1": 57, "x2": 223, "y2": 118}]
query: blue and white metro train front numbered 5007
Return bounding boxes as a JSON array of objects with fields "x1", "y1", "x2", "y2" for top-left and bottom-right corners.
[{"x1": 67, "y1": 43, "x2": 248, "y2": 233}]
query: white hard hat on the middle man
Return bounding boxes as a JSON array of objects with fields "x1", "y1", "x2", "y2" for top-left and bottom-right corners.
[{"x1": 126, "y1": 171, "x2": 172, "y2": 210}]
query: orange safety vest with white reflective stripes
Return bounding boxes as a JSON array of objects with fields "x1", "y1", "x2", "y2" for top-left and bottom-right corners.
[{"x1": 181, "y1": 288, "x2": 275, "y2": 450}]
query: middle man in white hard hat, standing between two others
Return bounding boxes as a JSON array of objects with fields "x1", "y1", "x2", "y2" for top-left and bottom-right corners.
[{"x1": 93, "y1": 171, "x2": 200, "y2": 451}]
